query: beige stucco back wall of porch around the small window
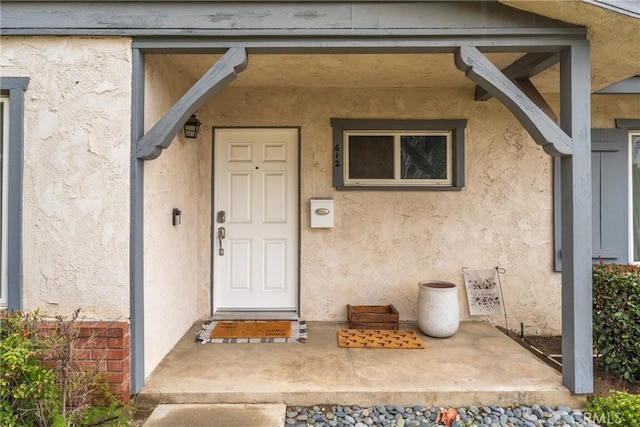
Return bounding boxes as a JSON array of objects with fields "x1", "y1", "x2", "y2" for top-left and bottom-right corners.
[{"x1": 200, "y1": 87, "x2": 561, "y2": 333}]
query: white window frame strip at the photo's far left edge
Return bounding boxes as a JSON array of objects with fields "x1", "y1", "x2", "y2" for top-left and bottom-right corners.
[{"x1": 0, "y1": 96, "x2": 9, "y2": 309}]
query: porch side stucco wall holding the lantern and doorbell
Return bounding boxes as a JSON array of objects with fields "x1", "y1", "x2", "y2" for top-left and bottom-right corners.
[{"x1": 144, "y1": 56, "x2": 202, "y2": 375}]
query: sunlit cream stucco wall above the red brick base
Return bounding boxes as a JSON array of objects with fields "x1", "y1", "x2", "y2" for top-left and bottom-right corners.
[{"x1": 0, "y1": 37, "x2": 131, "y2": 319}]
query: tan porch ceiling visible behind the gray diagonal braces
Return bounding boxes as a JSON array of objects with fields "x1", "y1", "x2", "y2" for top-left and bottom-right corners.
[{"x1": 160, "y1": 53, "x2": 558, "y2": 93}]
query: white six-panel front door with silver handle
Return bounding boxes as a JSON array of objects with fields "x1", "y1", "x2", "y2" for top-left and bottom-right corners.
[{"x1": 211, "y1": 128, "x2": 298, "y2": 317}]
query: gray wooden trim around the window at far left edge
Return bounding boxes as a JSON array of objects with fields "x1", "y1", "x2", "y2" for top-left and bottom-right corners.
[{"x1": 0, "y1": 77, "x2": 29, "y2": 310}]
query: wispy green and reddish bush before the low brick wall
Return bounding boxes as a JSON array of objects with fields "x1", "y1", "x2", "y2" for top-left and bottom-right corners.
[{"x1": 0, "y1": 310, "x2": 130, "y2": 427}]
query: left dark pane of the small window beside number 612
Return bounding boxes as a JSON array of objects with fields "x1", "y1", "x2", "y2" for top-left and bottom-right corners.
[{"x1": 349, "y1": 135, "x2": 394, "y2": 179}]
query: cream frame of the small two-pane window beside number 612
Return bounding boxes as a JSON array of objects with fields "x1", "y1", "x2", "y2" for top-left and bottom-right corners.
[{"x1": 343, "y1": 130, "x2": 453, "y2": 187}]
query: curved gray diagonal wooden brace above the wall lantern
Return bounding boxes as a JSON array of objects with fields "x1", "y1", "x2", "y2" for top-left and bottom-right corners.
[{"x1": 137, "y1": 48, "x2": 247, "y2": 160}]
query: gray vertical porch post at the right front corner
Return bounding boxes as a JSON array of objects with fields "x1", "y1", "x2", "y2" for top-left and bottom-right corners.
[{"x1": 560, "y1": 42, "x2": 593, "y2": 394}]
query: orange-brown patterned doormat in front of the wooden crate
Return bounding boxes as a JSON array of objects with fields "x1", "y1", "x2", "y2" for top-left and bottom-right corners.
[{"x1": 338, "y1": 329, "x2": 424, "y2": 349}]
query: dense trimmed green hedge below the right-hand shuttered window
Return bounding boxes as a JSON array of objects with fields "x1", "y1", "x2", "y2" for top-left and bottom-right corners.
[{"x1": 593, "y1": 264, "x2": 640, "y2": 382}]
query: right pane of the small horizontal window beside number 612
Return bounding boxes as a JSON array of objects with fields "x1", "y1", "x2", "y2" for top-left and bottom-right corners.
[{"x1": 400, "y1": 135, "x2": 447, "y2": 179}]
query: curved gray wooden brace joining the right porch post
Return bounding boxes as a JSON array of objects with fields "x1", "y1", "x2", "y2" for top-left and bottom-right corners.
[{"x1": 455, "y1": 47, "x2": 572, "y2": 156}]
